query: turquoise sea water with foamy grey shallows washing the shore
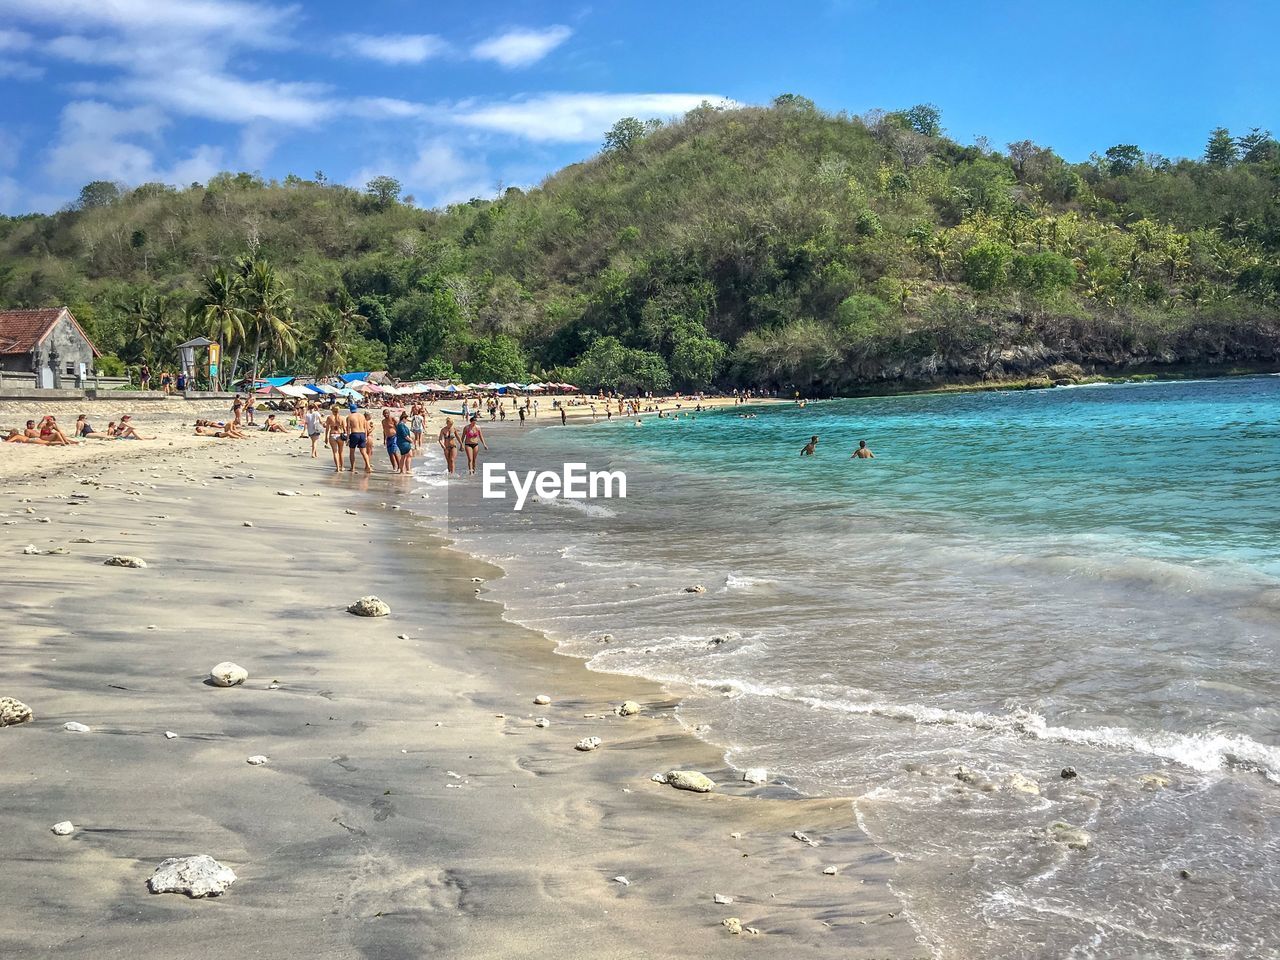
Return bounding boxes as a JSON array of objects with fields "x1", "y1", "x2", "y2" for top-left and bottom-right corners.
[{"x1": 424, "y1": 376, "x2": 1280, "y2": 957}]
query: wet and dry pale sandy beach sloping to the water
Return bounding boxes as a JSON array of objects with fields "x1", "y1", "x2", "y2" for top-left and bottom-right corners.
[{"x1": 0, "y1": 419, "x2": 928, "y2": 960}]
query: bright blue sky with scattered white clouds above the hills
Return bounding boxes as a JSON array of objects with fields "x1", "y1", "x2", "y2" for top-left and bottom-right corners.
[{"x1": 0, "y1": 0, "x2": 1280, "y2": 214}]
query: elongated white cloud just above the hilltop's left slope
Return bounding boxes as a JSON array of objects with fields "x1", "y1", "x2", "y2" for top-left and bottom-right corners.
[{"x1": 449, "y1": 93, "x2": 736, "y2": 143}]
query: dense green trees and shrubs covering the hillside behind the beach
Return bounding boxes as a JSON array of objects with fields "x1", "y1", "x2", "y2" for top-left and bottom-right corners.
[{"x1": 0, "y1": 95, "x2": 1280, "y2": 392}]
